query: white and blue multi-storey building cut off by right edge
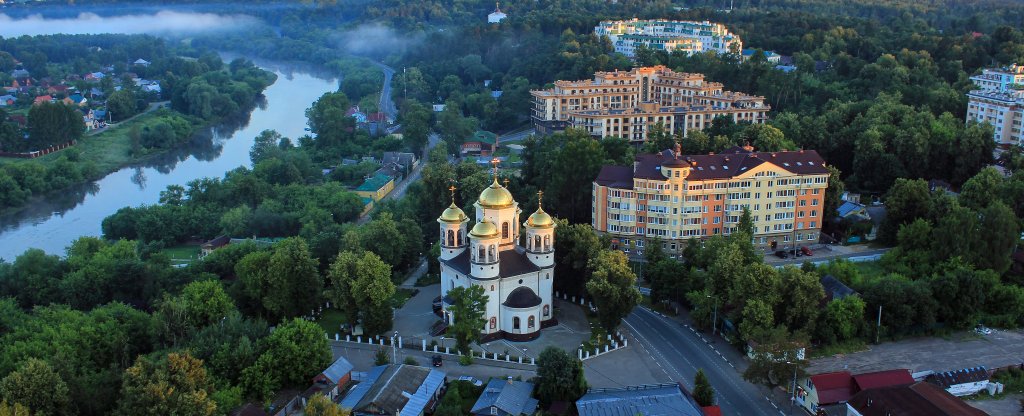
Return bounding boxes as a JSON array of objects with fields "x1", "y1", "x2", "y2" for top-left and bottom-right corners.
[{"x1": 967, "y1": 64, "x2": 1024, "y2": 147}]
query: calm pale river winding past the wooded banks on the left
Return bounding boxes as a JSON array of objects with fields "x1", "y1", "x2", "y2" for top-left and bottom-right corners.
[{"x1": 0, "y1": 60, "x2": 338, "y2": 261}]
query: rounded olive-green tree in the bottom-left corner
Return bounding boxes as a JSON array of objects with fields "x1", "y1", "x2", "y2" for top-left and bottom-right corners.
[{"x1": 0, "y1": 359, "x2": 71, "y2": 416}]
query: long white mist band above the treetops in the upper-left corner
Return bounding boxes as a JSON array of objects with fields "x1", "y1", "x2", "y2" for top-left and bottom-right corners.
[{"x1": 0, "y1": 10, "x2": 259, "y2": 38}]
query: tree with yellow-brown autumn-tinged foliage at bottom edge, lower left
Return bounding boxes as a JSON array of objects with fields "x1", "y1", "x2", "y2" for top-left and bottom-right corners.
[{"x1": 117, "y1": 352, "x2": 217, "y2": 416}]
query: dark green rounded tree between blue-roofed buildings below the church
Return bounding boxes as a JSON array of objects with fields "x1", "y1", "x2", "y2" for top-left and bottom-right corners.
[{"x1": 535, "y1": 346, "x2": 587, "y2": 406}]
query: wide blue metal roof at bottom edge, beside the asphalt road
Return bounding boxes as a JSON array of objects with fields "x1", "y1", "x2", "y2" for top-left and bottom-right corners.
[{"x1": 577, "y1": 384, "x2": 703, "y2": 416}]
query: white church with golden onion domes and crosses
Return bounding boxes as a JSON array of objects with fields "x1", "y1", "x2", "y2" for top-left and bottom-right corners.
[{"x1": 437, "y1": 162, "x2": 555, "y2": 341}]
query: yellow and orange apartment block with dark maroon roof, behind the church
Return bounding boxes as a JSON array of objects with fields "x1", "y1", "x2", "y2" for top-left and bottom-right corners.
[{"x1": 591, "y1": 144, "x2": 828, "y2": 252}]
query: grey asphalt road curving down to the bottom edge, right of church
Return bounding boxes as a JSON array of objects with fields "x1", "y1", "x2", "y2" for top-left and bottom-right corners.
[{"x1": 625, "y1": 307, "x2": 779, "y2": 416}]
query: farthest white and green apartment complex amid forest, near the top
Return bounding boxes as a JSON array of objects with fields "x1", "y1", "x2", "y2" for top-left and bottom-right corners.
[{"x1": 594, "y1": 18, "x2": 743, "y2": 57}]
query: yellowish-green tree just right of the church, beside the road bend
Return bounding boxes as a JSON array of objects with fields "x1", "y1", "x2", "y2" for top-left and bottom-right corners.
[{"x1": 587, "y1": 251, "x2": 641, "y2": 332}]
